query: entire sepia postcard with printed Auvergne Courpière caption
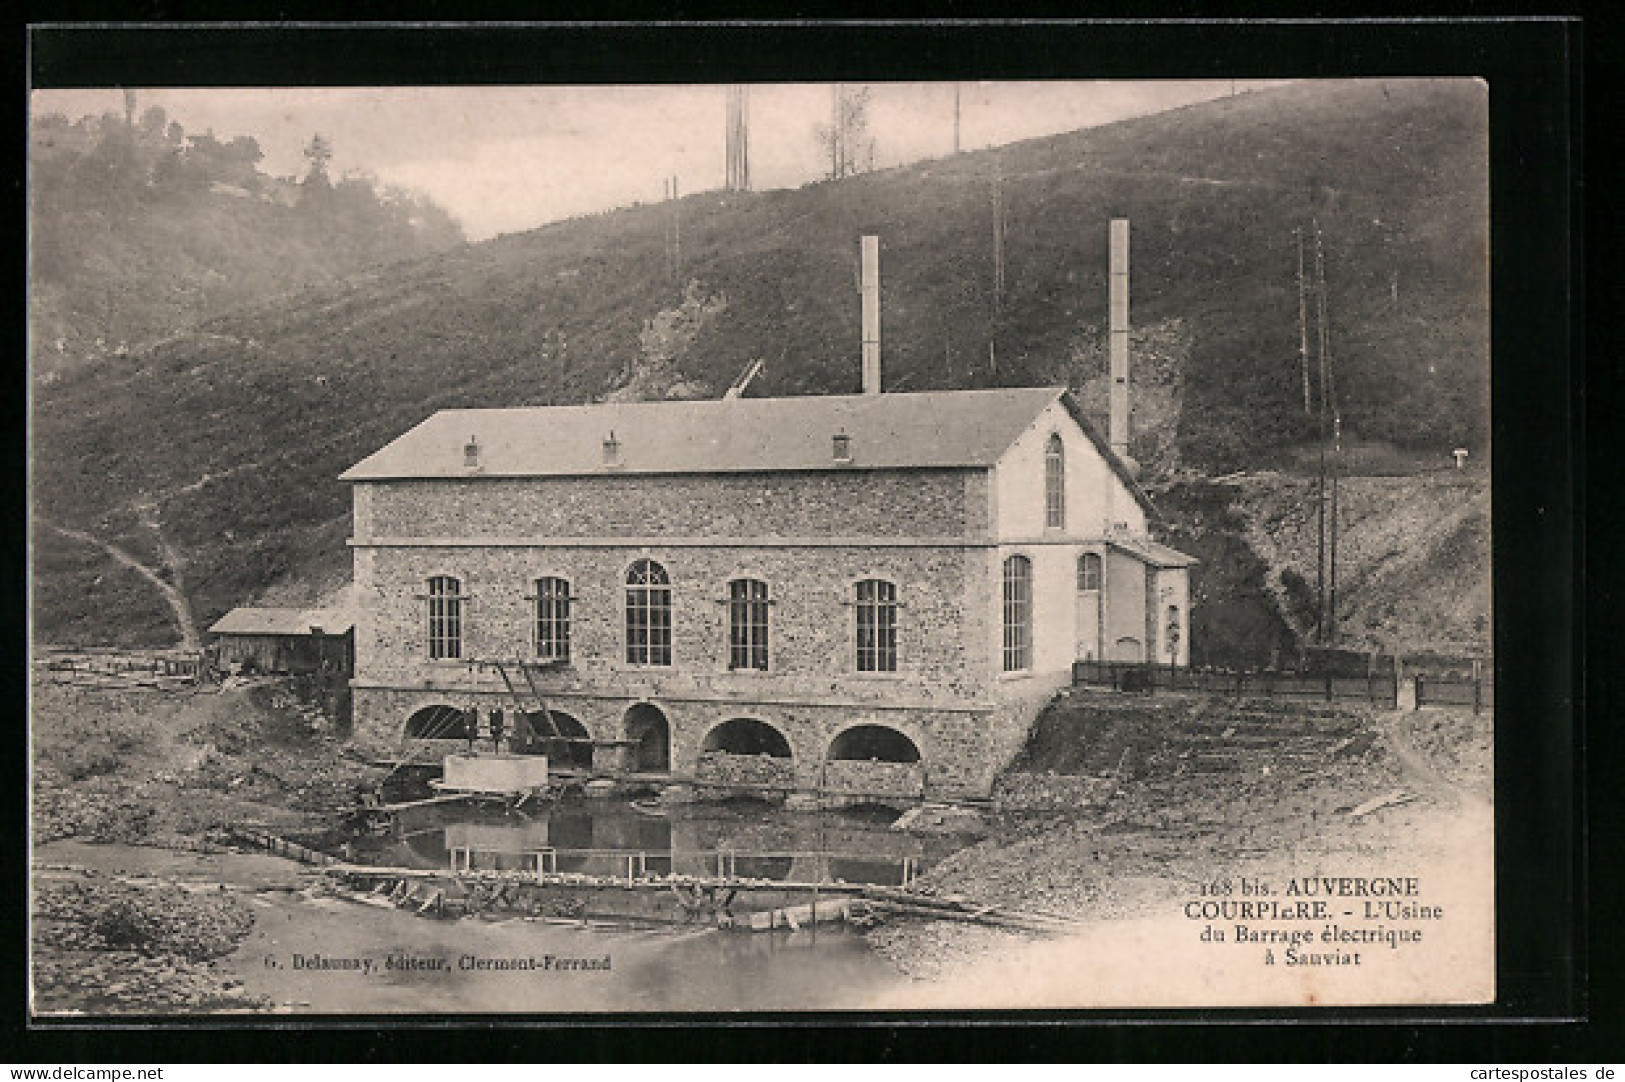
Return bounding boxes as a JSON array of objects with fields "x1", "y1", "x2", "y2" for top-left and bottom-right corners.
[{"x1": 29, "y1": 78, "x2": 1497, "y2": 1019}]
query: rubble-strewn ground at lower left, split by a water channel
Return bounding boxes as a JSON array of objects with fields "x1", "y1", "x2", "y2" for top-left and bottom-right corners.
[{"x1": 33, "y1": 676, "x2": 379, "y2": 1014}]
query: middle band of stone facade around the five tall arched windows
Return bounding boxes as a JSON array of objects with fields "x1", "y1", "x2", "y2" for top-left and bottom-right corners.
[{"x1": 356, "y1": 546, "x2": 993, "y2": 703}]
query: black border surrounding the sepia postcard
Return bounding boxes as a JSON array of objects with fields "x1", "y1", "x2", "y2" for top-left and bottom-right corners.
[{"x1": 3, "y1": 16, "x2": 1588, "y2": 1063}]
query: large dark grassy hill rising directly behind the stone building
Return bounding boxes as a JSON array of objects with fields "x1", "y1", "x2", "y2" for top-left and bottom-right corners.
[{"x1": 34, "y1": 81, "x2": 1489, "y2": 642}]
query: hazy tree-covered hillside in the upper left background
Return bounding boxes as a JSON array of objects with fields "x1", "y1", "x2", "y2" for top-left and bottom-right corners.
[{"x1": 29, "y1": 107, "x2": 462, "y2": 382}]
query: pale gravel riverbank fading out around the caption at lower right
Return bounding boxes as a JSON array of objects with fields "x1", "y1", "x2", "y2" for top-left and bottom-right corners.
[{"x1": 869, "y1": 698, "x2": 1493, "y2": 1007}]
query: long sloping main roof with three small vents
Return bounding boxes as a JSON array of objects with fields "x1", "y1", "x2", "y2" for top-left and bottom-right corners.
[{"x1": 341, "y1": 387, "x2": 1064, "y2": 481}]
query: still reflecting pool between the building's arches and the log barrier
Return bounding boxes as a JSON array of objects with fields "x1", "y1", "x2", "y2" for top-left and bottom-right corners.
[{"x1": 358, "y1": 798, "x2": 965, "y2": 885}]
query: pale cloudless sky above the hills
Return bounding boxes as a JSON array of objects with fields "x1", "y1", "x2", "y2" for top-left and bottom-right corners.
[{"x1": 31, "y1": 80, "x2": 1287, "y2": 240}]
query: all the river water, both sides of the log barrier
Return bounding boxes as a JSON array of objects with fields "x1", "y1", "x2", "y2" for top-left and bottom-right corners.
[{"x1": 37, "y1": 801, "x2": 965, "y2": 1014}]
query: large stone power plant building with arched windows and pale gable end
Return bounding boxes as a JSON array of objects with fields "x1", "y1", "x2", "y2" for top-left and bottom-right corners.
[{"x1": 343, "y1": 387, "x2": 1193, "y2": 796}]
